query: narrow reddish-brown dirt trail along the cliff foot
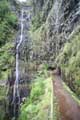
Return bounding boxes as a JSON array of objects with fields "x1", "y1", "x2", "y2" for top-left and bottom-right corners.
[{"x1": 53, "y1": 75, "x2": 80, "y2": 120}]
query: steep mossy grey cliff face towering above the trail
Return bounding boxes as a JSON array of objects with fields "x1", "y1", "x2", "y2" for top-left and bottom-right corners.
[{"x1": 31, "y1": 0, "x2": 80, "y2": 97}]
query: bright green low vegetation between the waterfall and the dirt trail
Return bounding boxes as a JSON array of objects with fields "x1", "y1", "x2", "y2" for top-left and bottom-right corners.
[{"x1": 19, "y1": 70, "x2": 57, "y2": 120}]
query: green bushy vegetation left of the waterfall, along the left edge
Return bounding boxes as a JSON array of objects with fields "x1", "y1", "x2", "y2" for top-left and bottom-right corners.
[{"x1": 0, "y1": 0, "x2": 17, "y2": 79}]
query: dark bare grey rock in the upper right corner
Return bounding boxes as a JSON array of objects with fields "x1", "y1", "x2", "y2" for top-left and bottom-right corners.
[{"x1": 61, "y1": 0, "x2": 80, "y2": 33}]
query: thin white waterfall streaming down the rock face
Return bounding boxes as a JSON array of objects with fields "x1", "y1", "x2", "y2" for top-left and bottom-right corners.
[{"x1": 13, "y1": 9, "x2": 24, "y2": 118}]
